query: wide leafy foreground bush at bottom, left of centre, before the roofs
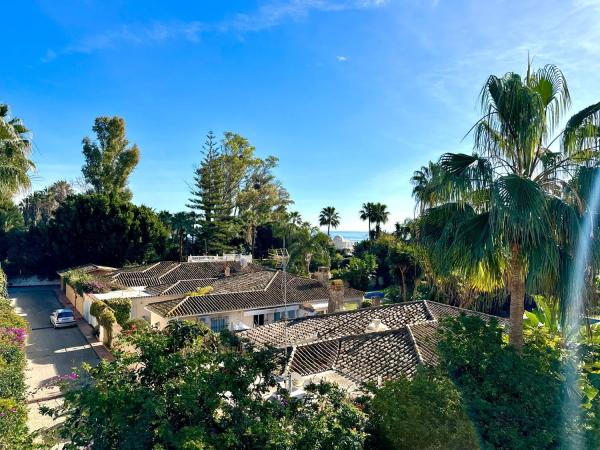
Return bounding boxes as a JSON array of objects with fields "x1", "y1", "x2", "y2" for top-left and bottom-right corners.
[{"x1": 47, "y1": 322, "x2": 366, "y2": 449}]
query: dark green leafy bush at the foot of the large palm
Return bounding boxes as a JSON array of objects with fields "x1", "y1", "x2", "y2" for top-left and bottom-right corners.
[{"x1": 439, "y1": 316, "x2": 597, "y2": 449}]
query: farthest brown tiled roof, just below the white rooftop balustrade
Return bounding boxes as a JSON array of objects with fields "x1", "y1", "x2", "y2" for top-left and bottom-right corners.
[{"x1": 107, "y1": 261, "x2": 266, "y2": 290}]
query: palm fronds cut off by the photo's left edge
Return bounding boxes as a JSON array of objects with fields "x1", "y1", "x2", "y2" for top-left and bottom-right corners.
[{"x1": 0, "y1": 104, "x2": 35, "y2": 198}]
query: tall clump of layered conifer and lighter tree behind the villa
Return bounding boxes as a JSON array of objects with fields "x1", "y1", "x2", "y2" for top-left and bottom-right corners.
[{"x1": 188, "y1": 132, "x2": 291, "y2": 254}]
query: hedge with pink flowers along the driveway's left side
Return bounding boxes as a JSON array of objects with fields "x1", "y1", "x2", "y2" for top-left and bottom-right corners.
[{"x1": 0, "y1": 270, "x2": 31, "y2": 449}]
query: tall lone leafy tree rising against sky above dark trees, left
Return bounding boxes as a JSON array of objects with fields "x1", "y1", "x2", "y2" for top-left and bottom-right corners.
[{"x1": 82, "y1": 116, "x2": 140, "y2": 200}]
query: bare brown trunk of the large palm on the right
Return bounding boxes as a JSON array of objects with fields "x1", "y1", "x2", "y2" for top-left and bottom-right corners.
[{"x1": 508, "y1": 244, "x2": 525, "y2": 350}]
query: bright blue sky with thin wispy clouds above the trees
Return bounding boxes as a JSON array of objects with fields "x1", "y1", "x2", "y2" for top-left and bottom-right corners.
[{"x1": 0, "y1": 0, "x2": 600, "y2": 230}]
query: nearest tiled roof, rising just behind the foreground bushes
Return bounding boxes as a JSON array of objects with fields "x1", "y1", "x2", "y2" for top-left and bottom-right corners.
[{"x1": 238, "y1": 301, "x2": 508, "y2": 385}]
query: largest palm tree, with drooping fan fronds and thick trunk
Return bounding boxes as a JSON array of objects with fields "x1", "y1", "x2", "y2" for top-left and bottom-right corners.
[{"x1": 417, "y1": 65, "x2": 600, "y2": 349}]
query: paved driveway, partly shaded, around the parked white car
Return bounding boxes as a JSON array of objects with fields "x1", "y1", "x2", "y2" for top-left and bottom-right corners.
[{"x1": 8, "y1": 287, "x2": 98, "y2": 430}]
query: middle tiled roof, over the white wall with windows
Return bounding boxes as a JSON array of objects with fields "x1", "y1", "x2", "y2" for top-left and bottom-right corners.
[{"x1": 147, "y1": 271, "x2": 362, "y2": 318}]
